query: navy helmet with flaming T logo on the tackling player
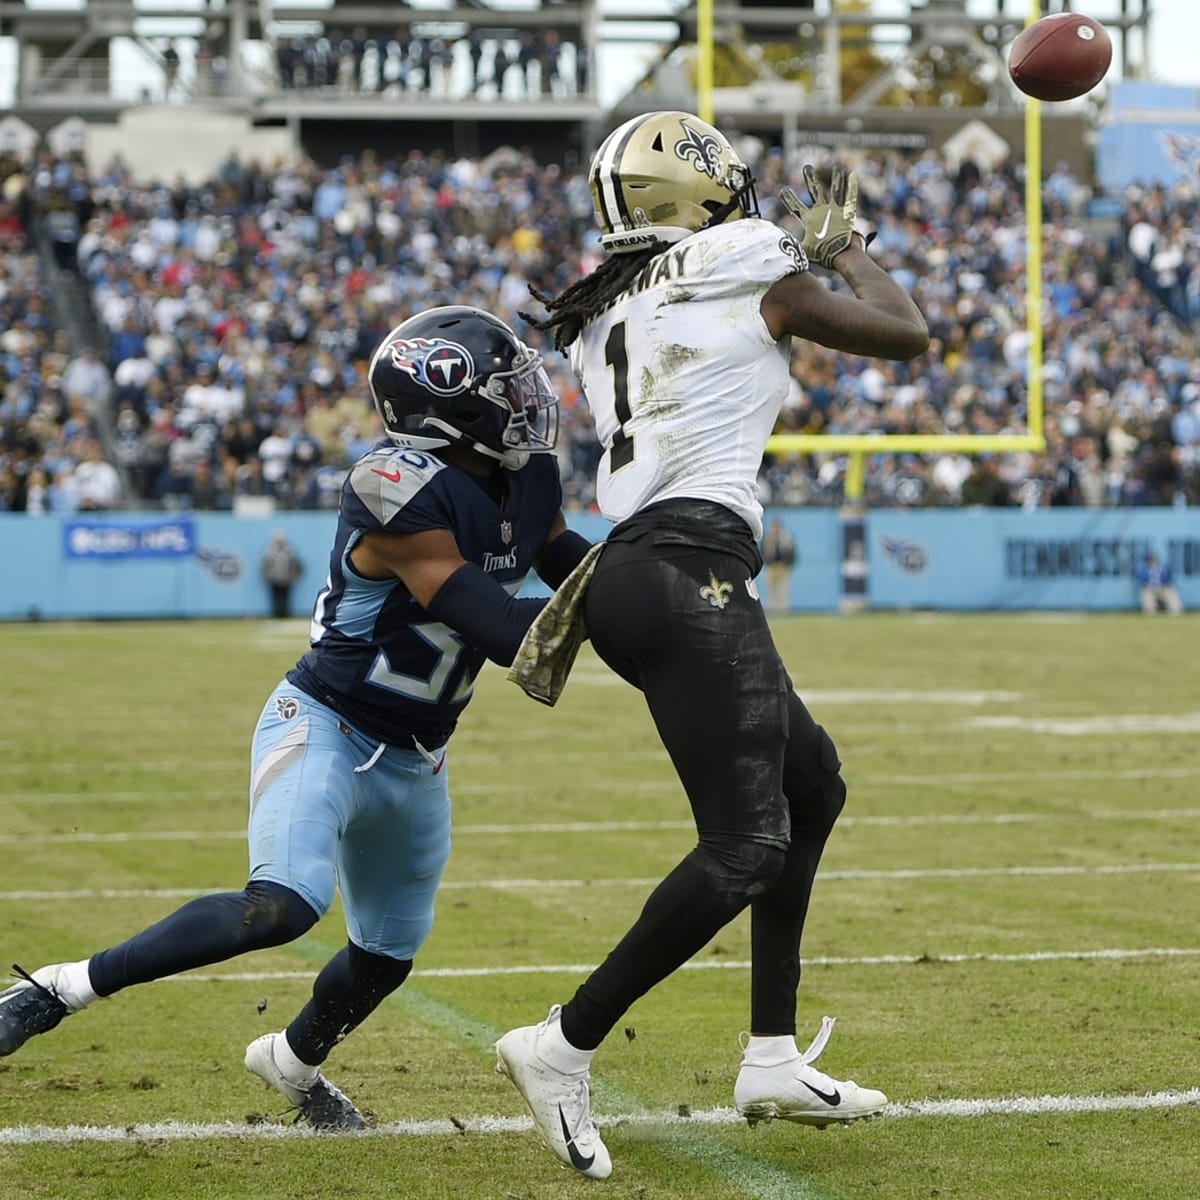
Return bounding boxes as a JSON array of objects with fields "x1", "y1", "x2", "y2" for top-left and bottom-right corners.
[{"x1": 367, "y1": 305, "x2": 558, "y2": 470}]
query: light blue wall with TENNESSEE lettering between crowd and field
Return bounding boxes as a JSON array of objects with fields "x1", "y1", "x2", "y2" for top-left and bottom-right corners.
[{"x1": 0, "y1": 508, "x2": 1200, "y2": 620}]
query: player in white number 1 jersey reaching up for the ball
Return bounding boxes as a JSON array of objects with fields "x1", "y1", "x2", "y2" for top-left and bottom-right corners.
[{"x1": 497, "y1": 112, "x2": 929, "y2": 1177}]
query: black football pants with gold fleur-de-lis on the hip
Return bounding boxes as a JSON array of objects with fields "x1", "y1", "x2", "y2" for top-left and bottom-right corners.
[{"x1": 563, "y1": 500, "x2": 846, "y2": 1049}]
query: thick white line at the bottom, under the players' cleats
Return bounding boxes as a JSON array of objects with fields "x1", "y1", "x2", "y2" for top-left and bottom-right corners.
[{"x1": 0, "y1": 1087, "x2": 1200, "y2": 1146}]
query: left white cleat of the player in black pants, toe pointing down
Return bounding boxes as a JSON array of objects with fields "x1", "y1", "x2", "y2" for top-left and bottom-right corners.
[{"x1": 496, "y1": 1004, "x2": 612, "y2": 1180}]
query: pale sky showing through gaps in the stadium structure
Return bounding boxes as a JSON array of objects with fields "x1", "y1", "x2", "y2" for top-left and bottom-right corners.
[{"x1": 0, "y1": 0, "x2": 1200, "y2": 106}]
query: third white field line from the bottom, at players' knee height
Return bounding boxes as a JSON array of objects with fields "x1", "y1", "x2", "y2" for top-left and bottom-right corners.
[{"x1": 0, "y1": 863, "x2": 1200, "y2": 901}]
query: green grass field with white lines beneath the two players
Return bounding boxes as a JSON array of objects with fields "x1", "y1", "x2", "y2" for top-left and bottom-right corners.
[{"x1": 0, "y1": 614, "x2": 1200, "y2": 1200}]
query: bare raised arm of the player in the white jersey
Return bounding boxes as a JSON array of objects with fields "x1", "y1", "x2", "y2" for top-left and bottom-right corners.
[{"x1": 760, "y1": 253, "x2": 929, "y2": 360}]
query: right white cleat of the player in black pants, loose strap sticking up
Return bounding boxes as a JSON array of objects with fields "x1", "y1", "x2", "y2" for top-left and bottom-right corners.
[{"x1": 733, "y1": 1016, "x2": 888, "y2": 1128}]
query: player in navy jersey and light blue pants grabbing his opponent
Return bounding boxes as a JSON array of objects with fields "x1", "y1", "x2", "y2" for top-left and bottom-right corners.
[{"x1": 0, "y1": 306, "x2": 589, "y2": 1129}]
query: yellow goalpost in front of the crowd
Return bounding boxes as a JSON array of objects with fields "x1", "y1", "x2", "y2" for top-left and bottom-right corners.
[{"x1": 696, "y1": 0, "x2": 1045, "y2": 505}]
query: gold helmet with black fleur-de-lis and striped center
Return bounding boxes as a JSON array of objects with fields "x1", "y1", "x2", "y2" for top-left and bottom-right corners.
[{"x1": 588, "y1": 113, "x2": 758, "y2": 254}]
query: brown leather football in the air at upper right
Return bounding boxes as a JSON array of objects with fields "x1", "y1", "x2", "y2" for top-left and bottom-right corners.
[{"x1": 1008, "y1": 12, "x2": 1112, "y2": 100}]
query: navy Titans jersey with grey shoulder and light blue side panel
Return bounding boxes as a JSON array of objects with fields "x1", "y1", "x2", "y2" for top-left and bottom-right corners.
[{"x1": 288, "y1": 442, "x2": 563, "y2": 750}]
